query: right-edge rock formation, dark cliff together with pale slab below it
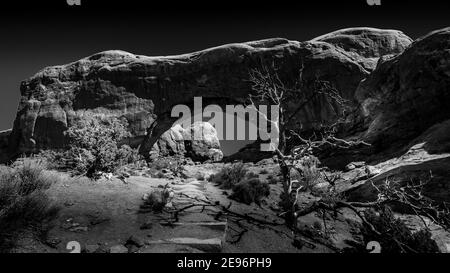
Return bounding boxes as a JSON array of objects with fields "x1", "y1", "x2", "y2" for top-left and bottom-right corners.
[{"x1": 346, "y1": 28, "x2": 450, "y2": 202}]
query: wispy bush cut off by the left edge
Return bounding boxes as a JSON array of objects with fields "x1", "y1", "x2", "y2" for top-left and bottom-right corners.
[{"x1": 0, "y1": 161, "x2": 58, "y2": 252}]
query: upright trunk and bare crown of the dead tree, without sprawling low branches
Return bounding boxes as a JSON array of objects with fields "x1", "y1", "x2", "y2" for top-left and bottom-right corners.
[{"x1": 249, "y1": 61, "x2": 368, "y2": 225}]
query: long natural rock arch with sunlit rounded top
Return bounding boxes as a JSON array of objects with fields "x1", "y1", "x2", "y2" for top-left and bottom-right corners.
[{"x1": 5, "y1": 28, "x2": 410, "y2": 159}]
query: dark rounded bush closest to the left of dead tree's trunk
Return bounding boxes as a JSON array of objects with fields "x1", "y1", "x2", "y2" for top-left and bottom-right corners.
[{"x1": 230, "y1": 178, "x2": 270, "y2": 205}]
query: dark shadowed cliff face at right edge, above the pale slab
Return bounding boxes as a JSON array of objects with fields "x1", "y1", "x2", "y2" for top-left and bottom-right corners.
[{"x1": 355, "y1": 28, "x2": 450, "y2": 150}]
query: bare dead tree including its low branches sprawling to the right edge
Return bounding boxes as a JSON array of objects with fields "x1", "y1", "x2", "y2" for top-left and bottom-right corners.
[{"x1": 249, "y1": 63, "x2": 450, "y2": 249}]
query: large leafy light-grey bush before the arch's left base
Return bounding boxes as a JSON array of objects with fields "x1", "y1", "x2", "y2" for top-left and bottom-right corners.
[{"x1": 60, "y1": 112, "x2": 139, "y2": 178}]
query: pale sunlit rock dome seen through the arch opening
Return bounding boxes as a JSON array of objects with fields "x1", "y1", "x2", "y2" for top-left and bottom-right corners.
[{"x1": 152, "y1": 122, "x2": 223, "y2": 162}]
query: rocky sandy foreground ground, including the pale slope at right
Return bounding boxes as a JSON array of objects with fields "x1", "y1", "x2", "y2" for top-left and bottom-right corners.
[{"x1": 9, "y1": 129, "x2": 450, "y2": 253}]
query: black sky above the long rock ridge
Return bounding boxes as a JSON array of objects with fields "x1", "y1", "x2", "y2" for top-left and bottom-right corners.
[{"x1": 0, "y1": 0, "x2": 450, "y2": 149}]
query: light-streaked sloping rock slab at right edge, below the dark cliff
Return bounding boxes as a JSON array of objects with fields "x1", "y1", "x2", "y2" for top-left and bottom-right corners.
[{"x1": 343, "y1": 120, "x2": 450, "y2": 202}]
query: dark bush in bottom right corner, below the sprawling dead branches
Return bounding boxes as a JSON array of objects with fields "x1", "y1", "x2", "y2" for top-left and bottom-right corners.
[{"x1": 361, "y1": 206, "x2": 440, "y2": 253}]
